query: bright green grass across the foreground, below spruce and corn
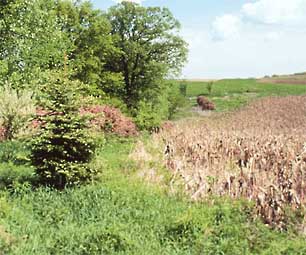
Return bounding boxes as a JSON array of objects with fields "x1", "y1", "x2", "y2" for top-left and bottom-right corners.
[{"x1": 0, "y1": 138, "x2": 306, "y2": 255}]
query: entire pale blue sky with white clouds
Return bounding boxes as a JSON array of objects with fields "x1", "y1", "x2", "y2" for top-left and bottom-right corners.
[{"x1": 92, "y1": 0, "x2": 306, "y2": 79}]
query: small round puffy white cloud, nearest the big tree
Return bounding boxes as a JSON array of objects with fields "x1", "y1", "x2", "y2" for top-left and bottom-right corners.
[{"x1": 212, "y1": 14, "x2": 241, "y2": 40}]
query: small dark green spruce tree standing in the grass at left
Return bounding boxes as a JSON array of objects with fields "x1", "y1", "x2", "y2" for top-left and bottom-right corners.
[{"x1": 31, "y1": 74, "x2": 95, "y2": 188}]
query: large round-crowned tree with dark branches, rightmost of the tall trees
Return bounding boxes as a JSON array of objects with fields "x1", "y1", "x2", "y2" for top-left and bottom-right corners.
[{"x1": 105, "y1": 2, "x2": 187, "y2": 109}]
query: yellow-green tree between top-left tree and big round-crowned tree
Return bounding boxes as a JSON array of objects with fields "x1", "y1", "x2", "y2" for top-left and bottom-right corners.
[{"x1": 57, "y1": 0, "x2": 123, "y2": 96}]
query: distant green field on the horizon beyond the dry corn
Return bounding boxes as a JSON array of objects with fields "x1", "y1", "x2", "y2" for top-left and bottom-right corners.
[{"x1": 171, "y1": 79, "x2": 306, "y2": 118}]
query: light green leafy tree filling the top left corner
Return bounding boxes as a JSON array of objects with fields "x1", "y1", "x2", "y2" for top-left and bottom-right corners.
[{"x1": 0, "y1": 0, "x2": 72, "y2": 86}]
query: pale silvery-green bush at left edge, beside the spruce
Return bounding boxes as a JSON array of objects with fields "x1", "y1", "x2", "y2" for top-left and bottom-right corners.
[{"x1": 0, "y1": 85, "x2": 35, "y2": 140}]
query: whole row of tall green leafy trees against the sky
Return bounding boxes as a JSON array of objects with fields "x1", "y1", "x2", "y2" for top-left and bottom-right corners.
[{"x1": 0, "y1": 0, "x2": 187, "y2": 129}]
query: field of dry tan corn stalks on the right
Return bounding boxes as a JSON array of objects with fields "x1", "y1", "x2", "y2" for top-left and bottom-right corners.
[{"x1": 155, "y1": 96, "x2": 306, "y2": 229}]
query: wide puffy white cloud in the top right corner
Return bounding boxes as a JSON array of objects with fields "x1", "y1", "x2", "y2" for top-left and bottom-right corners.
[{"x1": 242, "y1": 0, "x2": 306, "y2": 25}]
